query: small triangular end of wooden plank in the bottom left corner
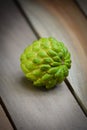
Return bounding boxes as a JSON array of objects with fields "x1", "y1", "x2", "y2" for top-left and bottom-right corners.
[{"x1": 0, "y1": 105, "x2": 13, "y2": 130}]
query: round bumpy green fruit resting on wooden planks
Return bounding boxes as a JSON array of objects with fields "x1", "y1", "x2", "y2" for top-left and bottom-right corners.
[{"x1": 20, "y1": 37, "x2": 71, "y2": 89}]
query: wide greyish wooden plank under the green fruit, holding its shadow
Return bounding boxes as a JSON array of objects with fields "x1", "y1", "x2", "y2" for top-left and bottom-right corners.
[{"x1": 0, "y1": 0, "x2": 87, "y2": 130}]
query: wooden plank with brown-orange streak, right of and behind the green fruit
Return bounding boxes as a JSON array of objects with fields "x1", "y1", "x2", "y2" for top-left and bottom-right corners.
[{"x1": 18, "y1": 0, "x2": 87, "y2": 114}]
